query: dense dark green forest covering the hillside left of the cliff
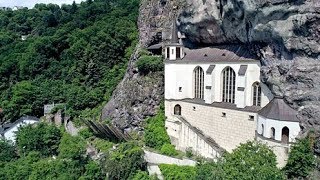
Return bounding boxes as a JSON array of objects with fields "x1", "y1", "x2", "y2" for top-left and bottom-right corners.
[{"x1": 0, "y1": 0, "x2": 139, "y2": 121}]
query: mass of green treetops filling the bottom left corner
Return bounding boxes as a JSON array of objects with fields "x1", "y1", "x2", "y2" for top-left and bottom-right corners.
[{"x1": 0, "y1": 123, "x2": 105, "y2": 180}]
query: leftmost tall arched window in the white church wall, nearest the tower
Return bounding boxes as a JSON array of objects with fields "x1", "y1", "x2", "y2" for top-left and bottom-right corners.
[{"x1": 193, "y1": 66, "x2": 204, "y2": 99}]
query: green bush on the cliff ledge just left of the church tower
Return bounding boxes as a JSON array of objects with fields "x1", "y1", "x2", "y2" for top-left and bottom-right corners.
[{"x1": 137, "y1": 55, "x2": 164, "y2": 74}]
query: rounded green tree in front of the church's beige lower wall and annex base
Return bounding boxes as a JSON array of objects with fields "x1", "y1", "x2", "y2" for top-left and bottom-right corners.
[{"x1": 222, "y1": 142, "x2": 284, "y2": 180}]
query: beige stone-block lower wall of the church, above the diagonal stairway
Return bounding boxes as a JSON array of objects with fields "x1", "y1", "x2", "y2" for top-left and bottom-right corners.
[{"x1": 165, "y1": 100, "x2": 257, "y2": 152}]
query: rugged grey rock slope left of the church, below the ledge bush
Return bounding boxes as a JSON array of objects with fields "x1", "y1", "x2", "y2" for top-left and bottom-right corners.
[{"x1": 101, "y1": 47, "x2": 164, "y2": 131}]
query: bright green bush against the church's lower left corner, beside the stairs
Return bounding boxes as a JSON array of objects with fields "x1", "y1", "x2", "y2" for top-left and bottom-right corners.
[{"x1": 144, "y1": 105, "x2": 170, "y2": 150}]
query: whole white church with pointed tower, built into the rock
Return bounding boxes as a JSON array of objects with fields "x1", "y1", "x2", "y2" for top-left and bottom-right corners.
[{"x1": 164, "y1": 20, "x2": 300, "y2": 166}]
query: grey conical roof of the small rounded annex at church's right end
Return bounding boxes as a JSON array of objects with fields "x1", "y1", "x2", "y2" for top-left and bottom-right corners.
[{"x1": 259, "y1": 97, "x2": 299, "y2": 122}]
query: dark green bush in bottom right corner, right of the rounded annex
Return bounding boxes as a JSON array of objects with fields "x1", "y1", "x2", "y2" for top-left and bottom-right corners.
[{"x1": 283, "y1": 137, "x2": 315, "y2": 178}]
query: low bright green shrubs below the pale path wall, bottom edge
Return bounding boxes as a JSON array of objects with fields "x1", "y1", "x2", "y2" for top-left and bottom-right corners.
[{"x1": 159, "y1": 164, "x2": 196, "y2": 180}]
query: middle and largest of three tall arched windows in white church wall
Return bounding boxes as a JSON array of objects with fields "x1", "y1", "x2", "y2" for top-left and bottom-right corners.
[{"x1": 222, "y1": 67, "x2": 236, "y2": 103}]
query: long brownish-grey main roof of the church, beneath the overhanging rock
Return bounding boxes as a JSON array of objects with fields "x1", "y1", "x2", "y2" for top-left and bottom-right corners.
[{"x1": 182, "y1": 45, "x2": 258, "y2": 62}]
